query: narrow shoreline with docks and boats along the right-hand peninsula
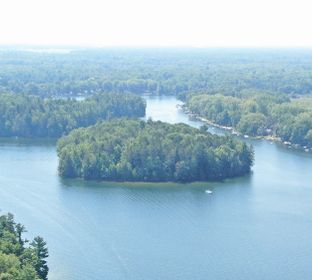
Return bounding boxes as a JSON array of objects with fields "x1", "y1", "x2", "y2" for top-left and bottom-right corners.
[{"x1": 182, "y1": 104, "x2": 312, "y2": 153}]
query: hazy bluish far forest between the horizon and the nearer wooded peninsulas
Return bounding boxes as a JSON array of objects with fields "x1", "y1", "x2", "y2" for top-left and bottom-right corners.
[{"x1": 0, "y1": 48, "x2": 312, "y2": 98}]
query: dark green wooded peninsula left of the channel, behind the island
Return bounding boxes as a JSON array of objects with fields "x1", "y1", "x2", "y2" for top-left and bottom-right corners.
[{"x1": 0, "y1": 93, "x2": 146, "y2": 137}]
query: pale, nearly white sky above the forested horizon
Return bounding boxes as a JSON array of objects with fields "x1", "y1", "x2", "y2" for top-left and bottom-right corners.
[{"x1": 0, "y1": 0, "x2": 312, "y2": 47}]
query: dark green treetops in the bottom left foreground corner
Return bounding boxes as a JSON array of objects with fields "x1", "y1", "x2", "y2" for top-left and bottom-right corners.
[{"x1": 0, "y1": 214, "x2": 49, "y2": 280}]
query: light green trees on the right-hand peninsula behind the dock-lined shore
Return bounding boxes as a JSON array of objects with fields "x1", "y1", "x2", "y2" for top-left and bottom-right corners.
[{"x1": 186, "y1": 92, "x2": 312, "y2": 147}]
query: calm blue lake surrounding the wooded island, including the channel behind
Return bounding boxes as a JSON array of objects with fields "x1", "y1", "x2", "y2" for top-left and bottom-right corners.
[{"x1": 0, "y1": 97, "x2": 312, "y2": 280}]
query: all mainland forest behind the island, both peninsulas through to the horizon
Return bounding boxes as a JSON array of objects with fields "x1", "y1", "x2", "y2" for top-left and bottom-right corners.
[{"x1": 0, "y1": 48, "x2": 312, "y2": 148}]
